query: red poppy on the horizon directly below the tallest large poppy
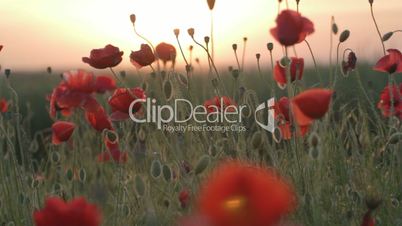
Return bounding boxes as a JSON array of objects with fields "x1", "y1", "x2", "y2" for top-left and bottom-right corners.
[{"x1": 274, "y1": 57, "x2": 304, "y2": 88}]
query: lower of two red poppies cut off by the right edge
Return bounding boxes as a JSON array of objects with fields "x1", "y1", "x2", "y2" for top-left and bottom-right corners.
[{"x1": 377, "y1": 84, "x2": 402, "y2": 119}]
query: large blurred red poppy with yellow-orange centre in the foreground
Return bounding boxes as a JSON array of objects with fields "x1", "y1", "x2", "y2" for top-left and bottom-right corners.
[{"x1": 198, "y1": 162, "x2": 295, "y2": 226}]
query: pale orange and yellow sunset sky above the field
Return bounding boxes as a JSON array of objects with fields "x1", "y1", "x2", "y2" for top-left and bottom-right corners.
[{"x1": 0, "y1": 0, "x2": 402, "y2": 70}]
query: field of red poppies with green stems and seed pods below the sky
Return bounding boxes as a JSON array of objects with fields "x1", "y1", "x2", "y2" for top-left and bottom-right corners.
[{"x1": 0, "y1": 0, "x2": 402, "y2": 226}]
